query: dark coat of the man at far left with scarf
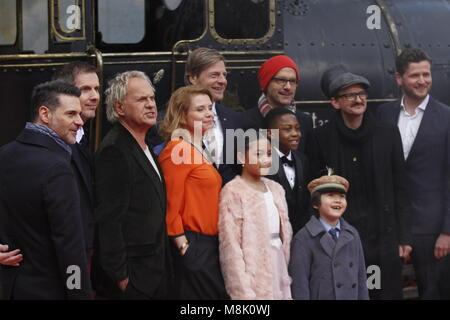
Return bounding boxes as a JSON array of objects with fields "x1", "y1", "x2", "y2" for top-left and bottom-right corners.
[{"x1": 0, "y1": 129, "x2": 92, "y2": 299}]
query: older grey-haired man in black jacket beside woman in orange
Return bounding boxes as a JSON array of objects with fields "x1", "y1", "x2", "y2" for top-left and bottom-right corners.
[{"x1": 95, "y1": 71, "x2": 172, "y2": 299}]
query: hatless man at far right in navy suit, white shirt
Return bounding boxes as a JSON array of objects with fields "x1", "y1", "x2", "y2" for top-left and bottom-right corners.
[{"x1": 378, "y1": 48, "x2": 450, "y2": 299}]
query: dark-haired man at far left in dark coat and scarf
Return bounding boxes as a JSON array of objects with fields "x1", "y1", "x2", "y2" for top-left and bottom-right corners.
[{"x1": 0, "y1": 81, "x2": 92, "y2": 299}]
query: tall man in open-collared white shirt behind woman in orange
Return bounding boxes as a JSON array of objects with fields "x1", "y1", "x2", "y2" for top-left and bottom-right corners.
[{"x1": 184, "y1": 48, "x2": 242, "y2": 184}]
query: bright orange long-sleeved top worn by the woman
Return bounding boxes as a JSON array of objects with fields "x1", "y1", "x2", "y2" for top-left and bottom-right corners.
[{"x1": 158, "y1": 139, "x2": 222, "y2": 236}]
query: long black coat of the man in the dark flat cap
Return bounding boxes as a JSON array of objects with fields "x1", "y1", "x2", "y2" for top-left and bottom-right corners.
[{"x1": 307, "y1": 113, "x2": 411, "y2": 299}]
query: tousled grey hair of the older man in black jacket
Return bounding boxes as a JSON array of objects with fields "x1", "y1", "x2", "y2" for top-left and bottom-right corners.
[{"x1": 105, "y1": 70, "x2": 155, "y2": 123}]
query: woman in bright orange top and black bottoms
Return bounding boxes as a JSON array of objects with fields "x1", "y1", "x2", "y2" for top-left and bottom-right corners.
[{"x1": 159, "y1": 86, "x2": 228, "y2": 299}]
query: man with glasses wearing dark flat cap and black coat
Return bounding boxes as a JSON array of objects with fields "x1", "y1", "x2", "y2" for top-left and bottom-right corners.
[{"x1": 307, "y1": 66, "x2": 412, "y2": 299}]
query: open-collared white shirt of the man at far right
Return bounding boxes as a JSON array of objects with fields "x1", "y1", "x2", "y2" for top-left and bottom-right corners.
[{"x1": 398, "y1": 95, "x2": 430, "y2": 160}]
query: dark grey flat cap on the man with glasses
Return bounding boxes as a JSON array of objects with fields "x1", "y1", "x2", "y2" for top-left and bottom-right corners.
[{"x1": 320, "y1": 65, "x2": 370, "y2": 98}]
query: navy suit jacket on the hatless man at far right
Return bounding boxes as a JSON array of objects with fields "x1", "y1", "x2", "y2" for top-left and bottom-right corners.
[{"x1": 377, "y1": 96, "x2": 450, "y2": 234}]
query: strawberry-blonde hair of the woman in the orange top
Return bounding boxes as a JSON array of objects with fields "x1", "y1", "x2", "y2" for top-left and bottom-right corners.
[{"x1": 159, "y1": 85, "x2": 212, "y2": 141}]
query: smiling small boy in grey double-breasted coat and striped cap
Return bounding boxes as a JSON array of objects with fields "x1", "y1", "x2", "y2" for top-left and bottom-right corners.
[{"x1": 289, "y1": 174, "x2": 369, "y2": 300}]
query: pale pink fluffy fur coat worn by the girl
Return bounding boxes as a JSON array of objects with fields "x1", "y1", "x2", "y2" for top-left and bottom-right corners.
[{"x1": 219, "y1": 176, "x2": 292, "y2": 300}]
